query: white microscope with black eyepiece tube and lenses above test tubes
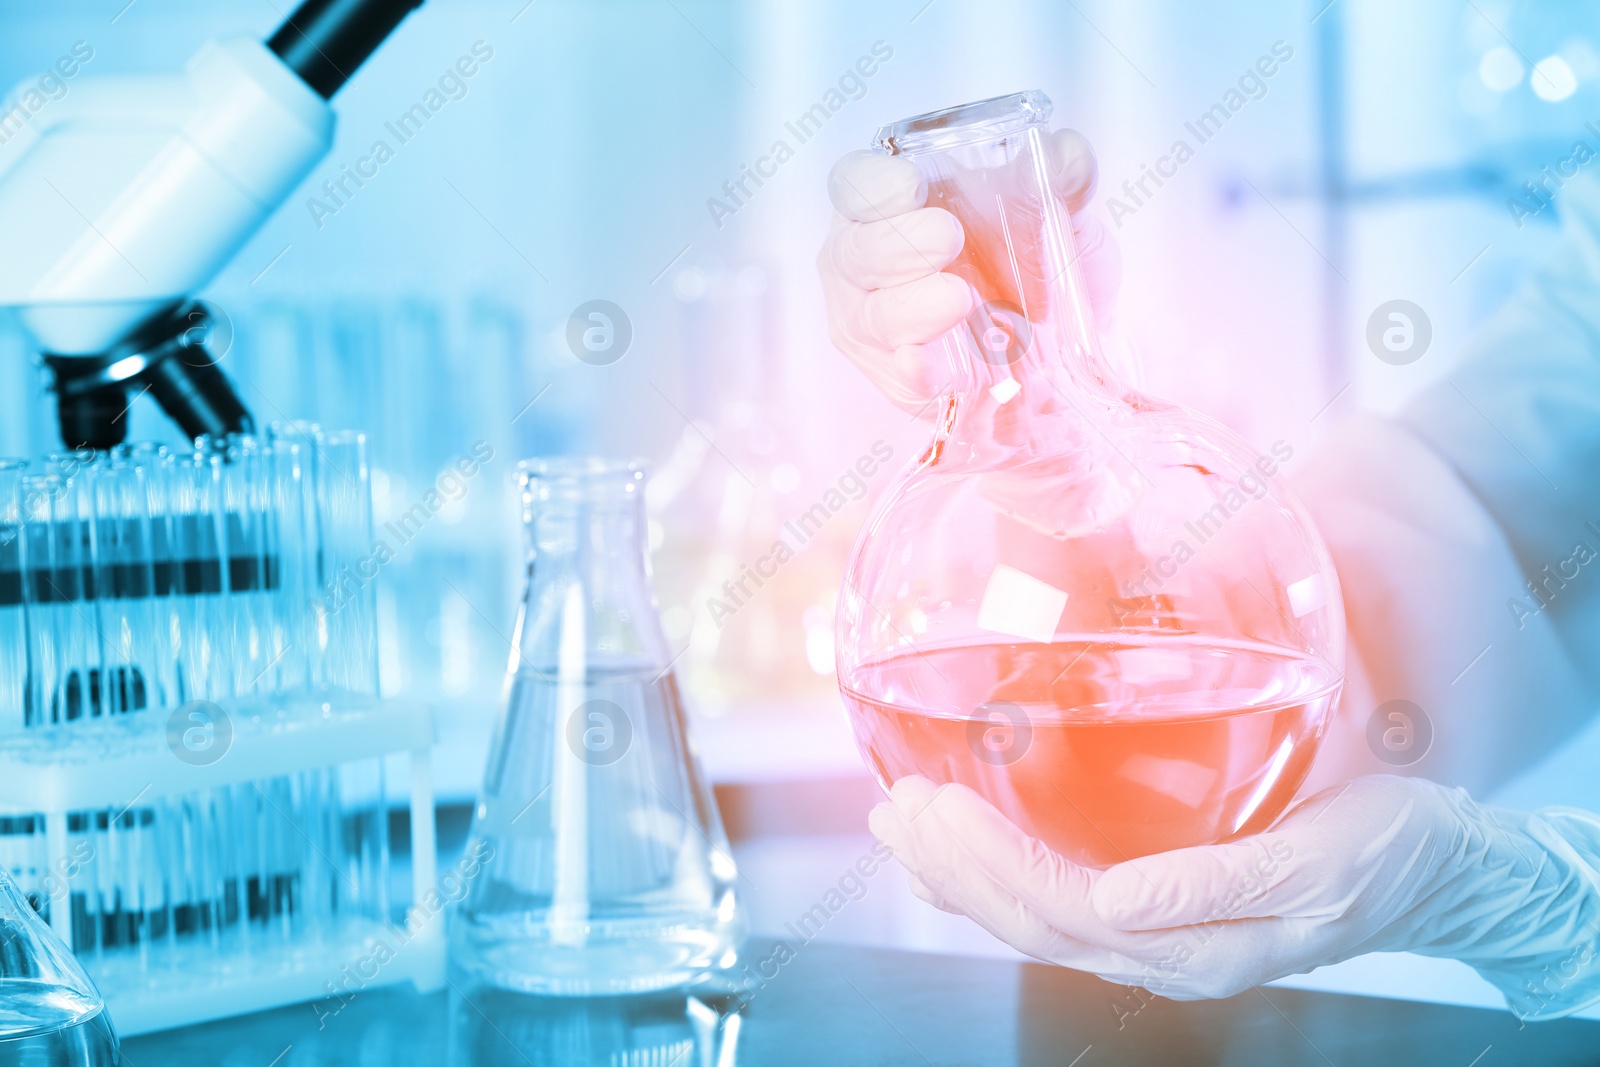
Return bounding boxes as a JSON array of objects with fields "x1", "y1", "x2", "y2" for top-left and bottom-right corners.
[{"x1": 0, "y1": 0, "x2": 422, "y2": 450}]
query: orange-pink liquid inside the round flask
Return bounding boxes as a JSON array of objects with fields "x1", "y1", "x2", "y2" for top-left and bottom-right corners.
[{"x1": 842, "y1": 635, "x2": 1339, "y2": 867}]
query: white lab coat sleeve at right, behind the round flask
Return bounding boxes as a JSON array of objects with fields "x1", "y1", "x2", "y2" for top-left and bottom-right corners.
[{"x1": 1296, "y1": 181, "x2": 1600, "y2": 793}]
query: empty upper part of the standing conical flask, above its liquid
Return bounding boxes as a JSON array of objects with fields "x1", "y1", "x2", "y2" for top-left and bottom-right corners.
[{"x1": 515, "y1": 459, "x2": 669, "y2": 672}]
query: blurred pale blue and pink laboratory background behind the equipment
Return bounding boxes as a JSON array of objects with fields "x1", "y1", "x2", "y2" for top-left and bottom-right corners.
[{"x1": 0, "y1": 0, "x2": 1600, "y2": 1005}]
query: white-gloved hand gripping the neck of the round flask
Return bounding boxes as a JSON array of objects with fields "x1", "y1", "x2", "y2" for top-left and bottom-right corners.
[{"x1": 816, "y1": 130, "x2": 1122, "y2": 413}]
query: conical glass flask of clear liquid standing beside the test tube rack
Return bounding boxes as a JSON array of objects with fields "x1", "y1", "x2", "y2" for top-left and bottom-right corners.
[{"x1": 451, "y1": 459, "x2": 742, "y2": 997}]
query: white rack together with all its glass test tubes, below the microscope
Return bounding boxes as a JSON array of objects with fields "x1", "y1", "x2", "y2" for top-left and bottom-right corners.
[{"x1": 0, "y1": 424, "x2": 445, "y2": 1033}]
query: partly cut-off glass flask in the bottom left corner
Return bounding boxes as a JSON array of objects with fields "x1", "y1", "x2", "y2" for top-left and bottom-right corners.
[{"x1": 0, "y1": 865, "x2": 120, "y2": 1067}]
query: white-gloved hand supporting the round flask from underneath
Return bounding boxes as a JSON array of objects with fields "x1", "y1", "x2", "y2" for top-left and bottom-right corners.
[{"x1": 870, "y1": 776, "x2": 1600, "y2": 1019}]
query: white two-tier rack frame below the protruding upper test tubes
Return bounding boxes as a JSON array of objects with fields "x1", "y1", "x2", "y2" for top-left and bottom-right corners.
[{"x1": 0, "y1": 696, "x2": 445, "y2": 1035}]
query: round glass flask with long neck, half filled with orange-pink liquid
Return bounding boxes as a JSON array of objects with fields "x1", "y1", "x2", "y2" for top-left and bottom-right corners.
[{"x1": 837, "y1": 91, "x2": 1344, "y2": 865}]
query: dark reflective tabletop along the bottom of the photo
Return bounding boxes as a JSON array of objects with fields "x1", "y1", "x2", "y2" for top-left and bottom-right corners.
[{"x1": 123, "y1": 941, "x2": 1600, "y2": 1067}]
